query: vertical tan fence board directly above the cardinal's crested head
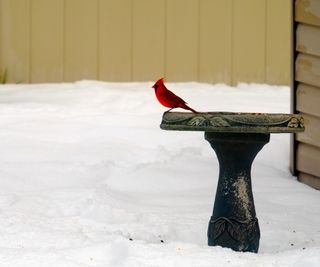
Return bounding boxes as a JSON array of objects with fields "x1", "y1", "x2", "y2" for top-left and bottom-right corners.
[{"x1": 132, "y1": 0, "x2": 166, "y2": 81}]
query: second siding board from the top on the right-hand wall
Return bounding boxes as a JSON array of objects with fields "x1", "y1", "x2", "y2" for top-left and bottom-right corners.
[{"x1": 296, "y1": 23, "x2": 320, "y2": 56}]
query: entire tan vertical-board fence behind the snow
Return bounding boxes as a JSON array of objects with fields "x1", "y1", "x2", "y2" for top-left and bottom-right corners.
[{"x1": 0, "y1": 0, "x2": 292, "y2": 85}]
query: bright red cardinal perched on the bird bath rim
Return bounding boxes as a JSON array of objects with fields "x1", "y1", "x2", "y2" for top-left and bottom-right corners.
[{"x1": 152, "y1": 78, "x2": 198, "y2": 113}]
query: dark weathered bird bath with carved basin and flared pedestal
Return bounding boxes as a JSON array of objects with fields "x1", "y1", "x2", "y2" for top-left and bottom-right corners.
[{"x1": 160, "y1": 112, "x2": 304, "y2": 252}]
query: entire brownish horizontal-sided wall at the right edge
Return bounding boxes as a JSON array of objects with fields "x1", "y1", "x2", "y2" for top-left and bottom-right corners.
[{"x1": 293, "y1": 0, "x2": 320, "y2": 189}]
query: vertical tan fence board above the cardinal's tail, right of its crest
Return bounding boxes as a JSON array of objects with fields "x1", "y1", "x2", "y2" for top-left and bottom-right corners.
[{"x1": 166, "y1": 0, "x2": 199, "y2": 81}]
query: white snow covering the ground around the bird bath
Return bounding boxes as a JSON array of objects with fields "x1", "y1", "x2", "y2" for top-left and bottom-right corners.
[{"x1": 0, "y1": 81, "x2": 320, "y2": 267}]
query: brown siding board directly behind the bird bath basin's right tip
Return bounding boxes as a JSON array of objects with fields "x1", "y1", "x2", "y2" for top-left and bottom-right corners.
[{"x1": 297, "y1": 114, "x2": 320, "y2": 149}]
